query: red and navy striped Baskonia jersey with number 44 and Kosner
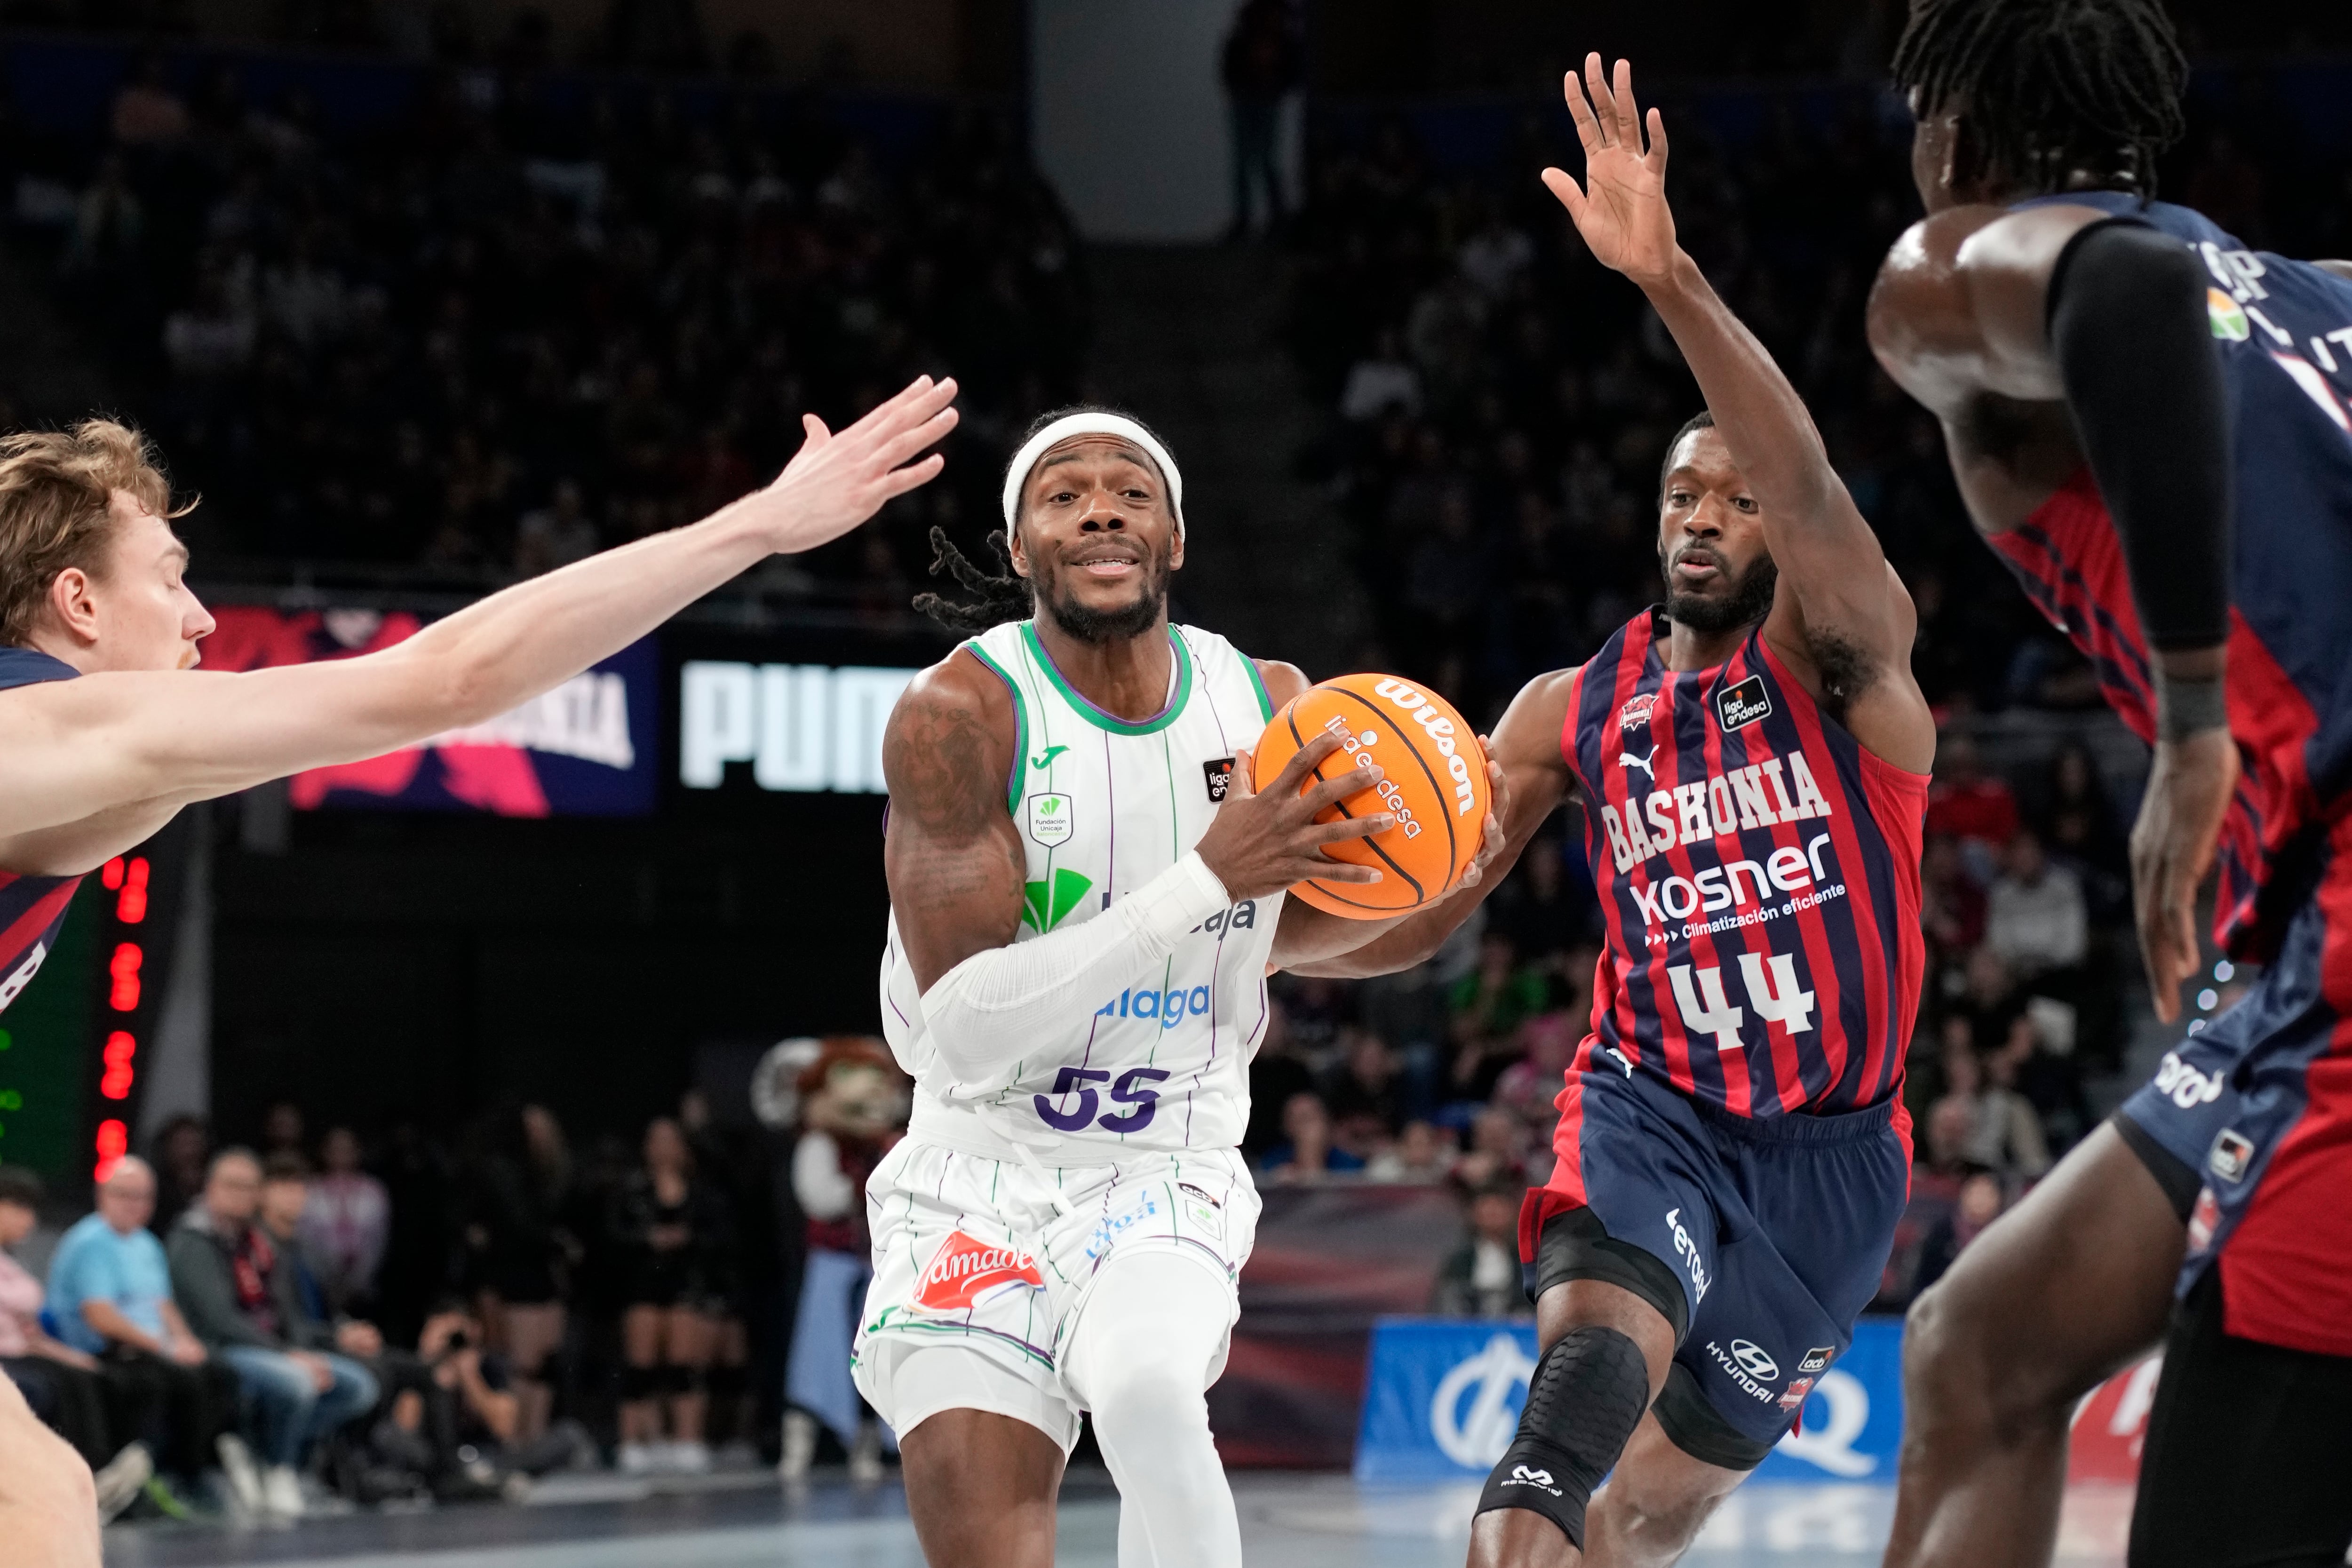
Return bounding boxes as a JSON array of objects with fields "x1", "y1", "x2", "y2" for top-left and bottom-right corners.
[{"x1": 1559, "y1": 609, "x2": 1926, "y2": 1117}]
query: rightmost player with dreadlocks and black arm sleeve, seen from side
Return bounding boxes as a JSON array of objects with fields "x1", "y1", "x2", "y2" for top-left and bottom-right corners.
[{"x1": 1870, "y1": 0, "x2": 2352, "y2": 1568}]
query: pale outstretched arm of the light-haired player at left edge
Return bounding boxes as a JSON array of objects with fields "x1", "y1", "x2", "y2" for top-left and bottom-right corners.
[{"x1": 0, "y1": 376, "x2": 955, "y2": 835}]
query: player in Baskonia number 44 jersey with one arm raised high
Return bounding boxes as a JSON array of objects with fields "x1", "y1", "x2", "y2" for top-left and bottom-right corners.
[{"x1": 1317, "y1": 54, "x2": 1936, "y2": 1568}]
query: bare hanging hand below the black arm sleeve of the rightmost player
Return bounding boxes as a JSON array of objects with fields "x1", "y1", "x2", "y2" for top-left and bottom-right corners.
[{"x1": 2131, "y1": 729, "x2": 2239, "y2": 1023}]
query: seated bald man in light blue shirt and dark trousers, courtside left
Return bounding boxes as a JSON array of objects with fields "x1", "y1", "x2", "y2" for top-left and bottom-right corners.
[{"x1": 49, "y1": 1157, "x2": 246, "y2": 1516}]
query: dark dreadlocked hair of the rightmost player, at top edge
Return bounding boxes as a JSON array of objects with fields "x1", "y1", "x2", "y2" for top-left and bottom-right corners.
[{"x1": 1893, "y1": 0, "x2": 2187, "y2": 198}]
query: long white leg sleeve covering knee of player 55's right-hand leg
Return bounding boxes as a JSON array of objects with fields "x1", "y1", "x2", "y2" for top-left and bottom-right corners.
[{"x1": 1063, "y1": 1250, "x2": 1242, "y2": 1568}]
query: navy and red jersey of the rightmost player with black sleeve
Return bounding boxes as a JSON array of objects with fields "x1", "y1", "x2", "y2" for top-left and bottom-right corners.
[{"x1": 1992, "y1": 191, "x2": 2352, "y2": 959}]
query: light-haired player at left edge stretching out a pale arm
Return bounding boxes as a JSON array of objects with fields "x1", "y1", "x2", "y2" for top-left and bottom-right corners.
[{"x1": 0, "y1": 376, "x2": 955, "y2": 1568}]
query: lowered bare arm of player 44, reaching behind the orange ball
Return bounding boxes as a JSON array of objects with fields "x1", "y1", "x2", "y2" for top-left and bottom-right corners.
[{"x1": 1282, "y1": 670, "x2": 1576, "y2": 980}]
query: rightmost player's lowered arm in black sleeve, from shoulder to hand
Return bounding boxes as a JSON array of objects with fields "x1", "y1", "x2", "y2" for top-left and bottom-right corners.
[{"x1": 1870, "y1": 205, "x2": 2239, "y2": 1023}]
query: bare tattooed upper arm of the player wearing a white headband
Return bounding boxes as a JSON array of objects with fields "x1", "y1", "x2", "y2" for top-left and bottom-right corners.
[{"x1": 882, "y1": 649, "x2": 1021, "y2": 990}]
